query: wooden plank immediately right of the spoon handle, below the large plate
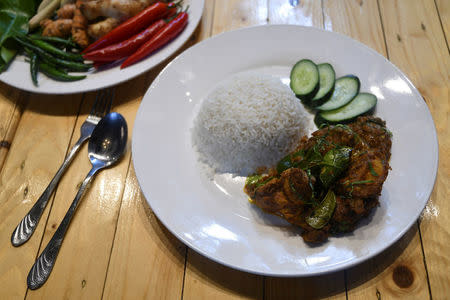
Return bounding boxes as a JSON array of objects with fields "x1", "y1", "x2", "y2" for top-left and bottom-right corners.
[{"x1": 103, "y1": 166, "x2": 186, "y2": 299}]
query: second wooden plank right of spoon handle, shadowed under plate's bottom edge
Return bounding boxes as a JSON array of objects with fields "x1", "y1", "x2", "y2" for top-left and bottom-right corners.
[{"x1": 183, "y1": 250, "x2": 263, "y2": 300}]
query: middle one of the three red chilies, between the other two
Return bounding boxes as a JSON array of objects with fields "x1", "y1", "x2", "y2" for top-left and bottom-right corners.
[{"x1": 83, "y1": 20, "x2": 166, "y2": 61}]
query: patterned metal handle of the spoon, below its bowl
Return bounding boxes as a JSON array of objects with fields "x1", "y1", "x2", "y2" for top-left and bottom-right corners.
[{"x1": 27, "y1": 167, "x2": 99, "y2": 290}]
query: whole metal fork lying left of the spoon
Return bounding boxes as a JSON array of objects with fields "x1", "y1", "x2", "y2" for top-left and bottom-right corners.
[{"x1": 11, "y1": 89, "x2": 114, "y2": 247}]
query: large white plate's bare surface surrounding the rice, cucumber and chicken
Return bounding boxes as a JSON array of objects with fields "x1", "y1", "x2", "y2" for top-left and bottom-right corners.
[{"x1": 132, "y1": 25, "x2": 438, "y2": 276}]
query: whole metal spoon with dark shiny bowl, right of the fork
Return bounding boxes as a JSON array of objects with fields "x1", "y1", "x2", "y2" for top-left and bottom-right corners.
[{"x1": 27, "y1": 113, "x2": 128, "y2": 290}]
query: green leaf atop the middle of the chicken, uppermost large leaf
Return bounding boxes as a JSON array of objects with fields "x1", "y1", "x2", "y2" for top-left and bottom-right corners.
[{"x1": 319, "y1": 147, "x2": 352, "y2": 187}]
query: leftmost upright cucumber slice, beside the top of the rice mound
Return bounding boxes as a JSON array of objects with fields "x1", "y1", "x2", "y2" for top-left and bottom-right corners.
[{"x1": 290, "y1": 59, "x2": 319, "y2": 99}]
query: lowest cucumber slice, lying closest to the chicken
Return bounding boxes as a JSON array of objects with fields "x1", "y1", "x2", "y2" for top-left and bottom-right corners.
[{"x1": 319, "y1": 93, "x2": 377, "y2": 123}]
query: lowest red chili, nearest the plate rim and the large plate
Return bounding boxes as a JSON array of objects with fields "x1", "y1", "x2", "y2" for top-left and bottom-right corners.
[{"x1": 120, "y1": 12, "x2": 188, "y2": 69}]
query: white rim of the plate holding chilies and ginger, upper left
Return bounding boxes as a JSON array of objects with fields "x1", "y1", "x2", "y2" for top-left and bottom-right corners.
[{"x1": 0, "y1": 0, "x2": 204, "y2": 94}]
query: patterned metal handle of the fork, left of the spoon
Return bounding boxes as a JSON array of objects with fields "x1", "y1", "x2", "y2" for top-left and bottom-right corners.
[{"x1": 11, "y1": 136, "x2": 89, "y2": 247}]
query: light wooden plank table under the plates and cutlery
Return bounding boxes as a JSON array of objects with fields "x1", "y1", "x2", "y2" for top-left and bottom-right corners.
[{"x1": 0, "y1": 0, "x2": 450, "y2": 299}]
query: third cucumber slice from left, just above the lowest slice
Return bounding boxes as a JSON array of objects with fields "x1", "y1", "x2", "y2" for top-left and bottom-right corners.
[{"x1": 316, "y1": 75, "x2": 360, "y2": 110}]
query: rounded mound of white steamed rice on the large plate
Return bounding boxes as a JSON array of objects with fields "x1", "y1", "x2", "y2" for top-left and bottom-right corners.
[{"x1": 192, "y1": 74, "x2": 309, "y2": 176}]
